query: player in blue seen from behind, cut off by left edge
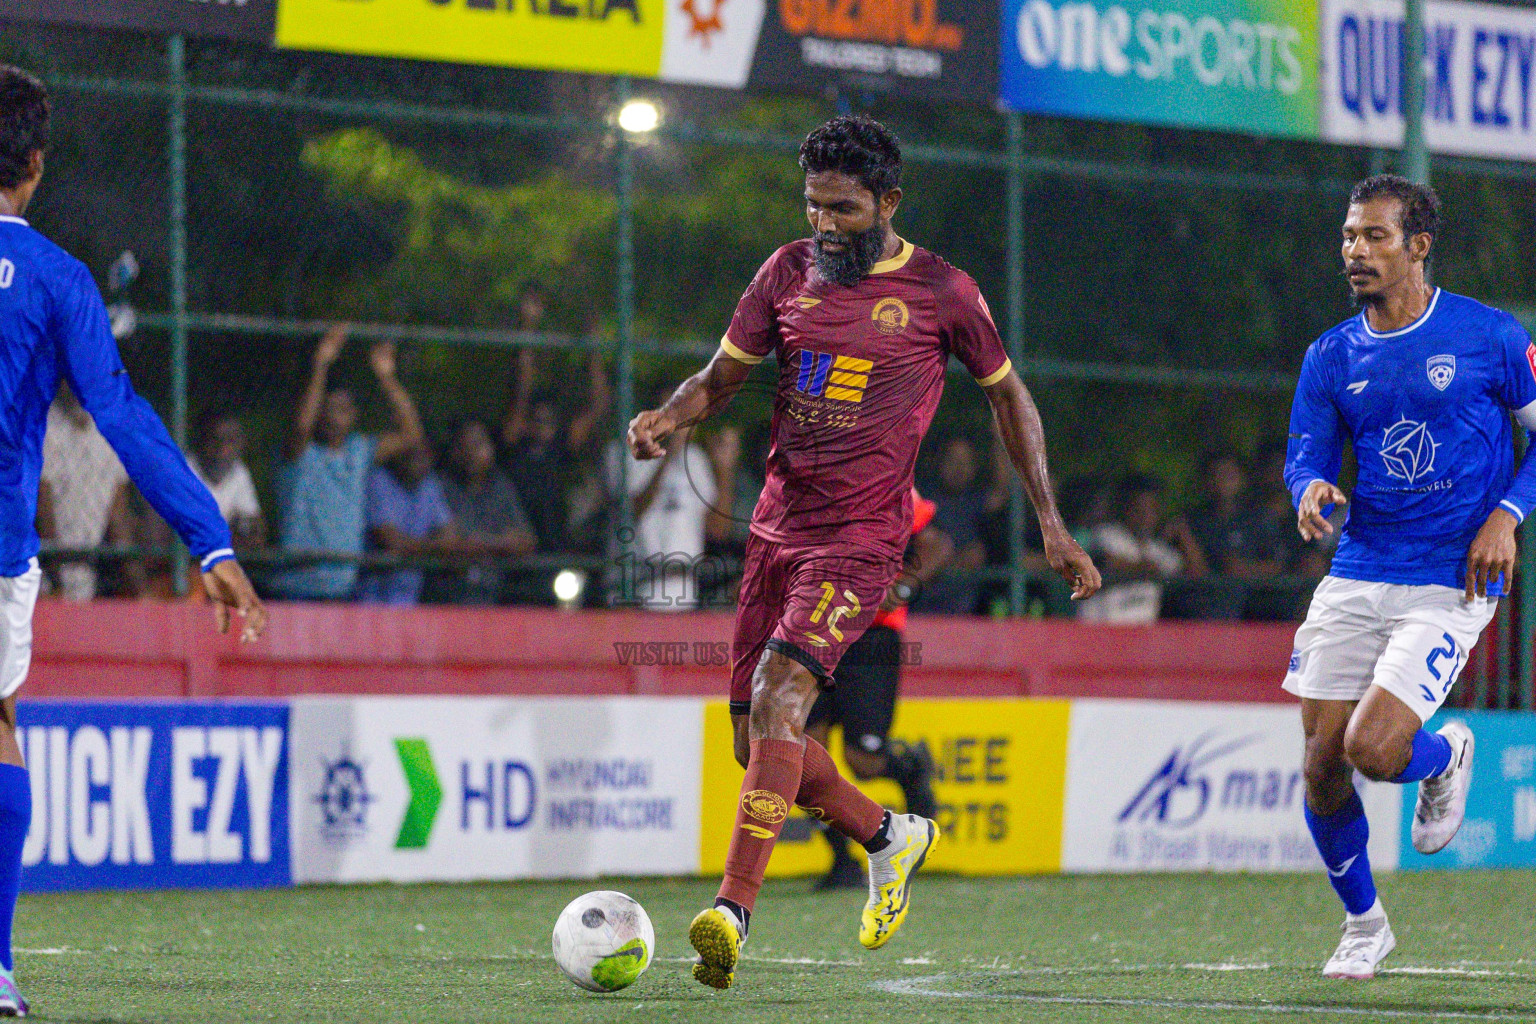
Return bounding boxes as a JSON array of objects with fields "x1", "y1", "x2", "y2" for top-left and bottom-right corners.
[{"x1": 0, "y1": 64, "x2": 266, "y2": 1016}]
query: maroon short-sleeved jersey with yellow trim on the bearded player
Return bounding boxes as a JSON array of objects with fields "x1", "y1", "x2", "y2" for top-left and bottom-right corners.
[{"x1": 720, "y1": 239, "x2": 1011, "y2": 559}]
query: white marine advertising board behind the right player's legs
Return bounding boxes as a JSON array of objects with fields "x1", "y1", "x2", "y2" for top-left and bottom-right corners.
[{"x1": 1061, "y1": 700, "x2": 1402, "y2": 872}]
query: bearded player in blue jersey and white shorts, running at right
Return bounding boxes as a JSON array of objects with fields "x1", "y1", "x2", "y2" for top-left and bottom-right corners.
[{"x1": 1284, "y1": 175, "x2": 1536, "y2": 978}]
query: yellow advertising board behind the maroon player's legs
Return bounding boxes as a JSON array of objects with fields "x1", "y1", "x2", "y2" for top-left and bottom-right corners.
[{"x1": 699, "y1": 700, "x2": 1071, "y2": 877}]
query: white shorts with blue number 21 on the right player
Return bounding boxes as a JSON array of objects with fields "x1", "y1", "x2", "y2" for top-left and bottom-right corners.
[{"x1": 1283, "y1": 576, "x2": 1499, "y2": 722}]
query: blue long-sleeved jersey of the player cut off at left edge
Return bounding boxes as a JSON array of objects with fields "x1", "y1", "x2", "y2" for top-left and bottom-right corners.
[{"x1": 0, "y1": 216, "x2": 233, "y2": 576}]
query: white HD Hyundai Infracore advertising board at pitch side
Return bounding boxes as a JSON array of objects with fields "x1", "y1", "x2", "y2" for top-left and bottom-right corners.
[{"x1": 290, "y1": 697, "x2": 703, "y2": 883}]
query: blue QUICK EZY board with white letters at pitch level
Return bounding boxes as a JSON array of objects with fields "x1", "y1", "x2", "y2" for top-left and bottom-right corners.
[{"x1": 17, "y1": 700, "x2": 292, "y2": 892}]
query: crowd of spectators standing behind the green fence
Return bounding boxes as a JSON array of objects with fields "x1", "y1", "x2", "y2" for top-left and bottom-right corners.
[{"x1": 38, "y1": 290, "x2": 1329, "y2": 623}]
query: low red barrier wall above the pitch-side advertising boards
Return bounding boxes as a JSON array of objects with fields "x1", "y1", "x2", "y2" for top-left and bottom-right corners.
[{"x1": 25, "y1": 600, "x2": 1295, "y2": 702}]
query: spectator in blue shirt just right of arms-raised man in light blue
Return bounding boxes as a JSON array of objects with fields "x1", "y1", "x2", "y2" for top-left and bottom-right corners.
[{"x1": 359, "y1": 444, "x2": 462, "y2": 605}]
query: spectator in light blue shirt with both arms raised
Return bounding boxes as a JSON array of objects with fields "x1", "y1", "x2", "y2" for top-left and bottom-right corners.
[{"x1": 272, "y1": 325, "x2": 425, "y2": 600}]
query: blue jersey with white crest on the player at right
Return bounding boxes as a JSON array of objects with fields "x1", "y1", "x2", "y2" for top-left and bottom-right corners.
[{"x1": 1286, "y1": 289, "x2": 1536, "y2": 594}]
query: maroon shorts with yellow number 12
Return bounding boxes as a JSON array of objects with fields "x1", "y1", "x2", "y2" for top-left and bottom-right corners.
[{"x1": 731, "y1": 533, "x2": 902, "y2": 714}]
